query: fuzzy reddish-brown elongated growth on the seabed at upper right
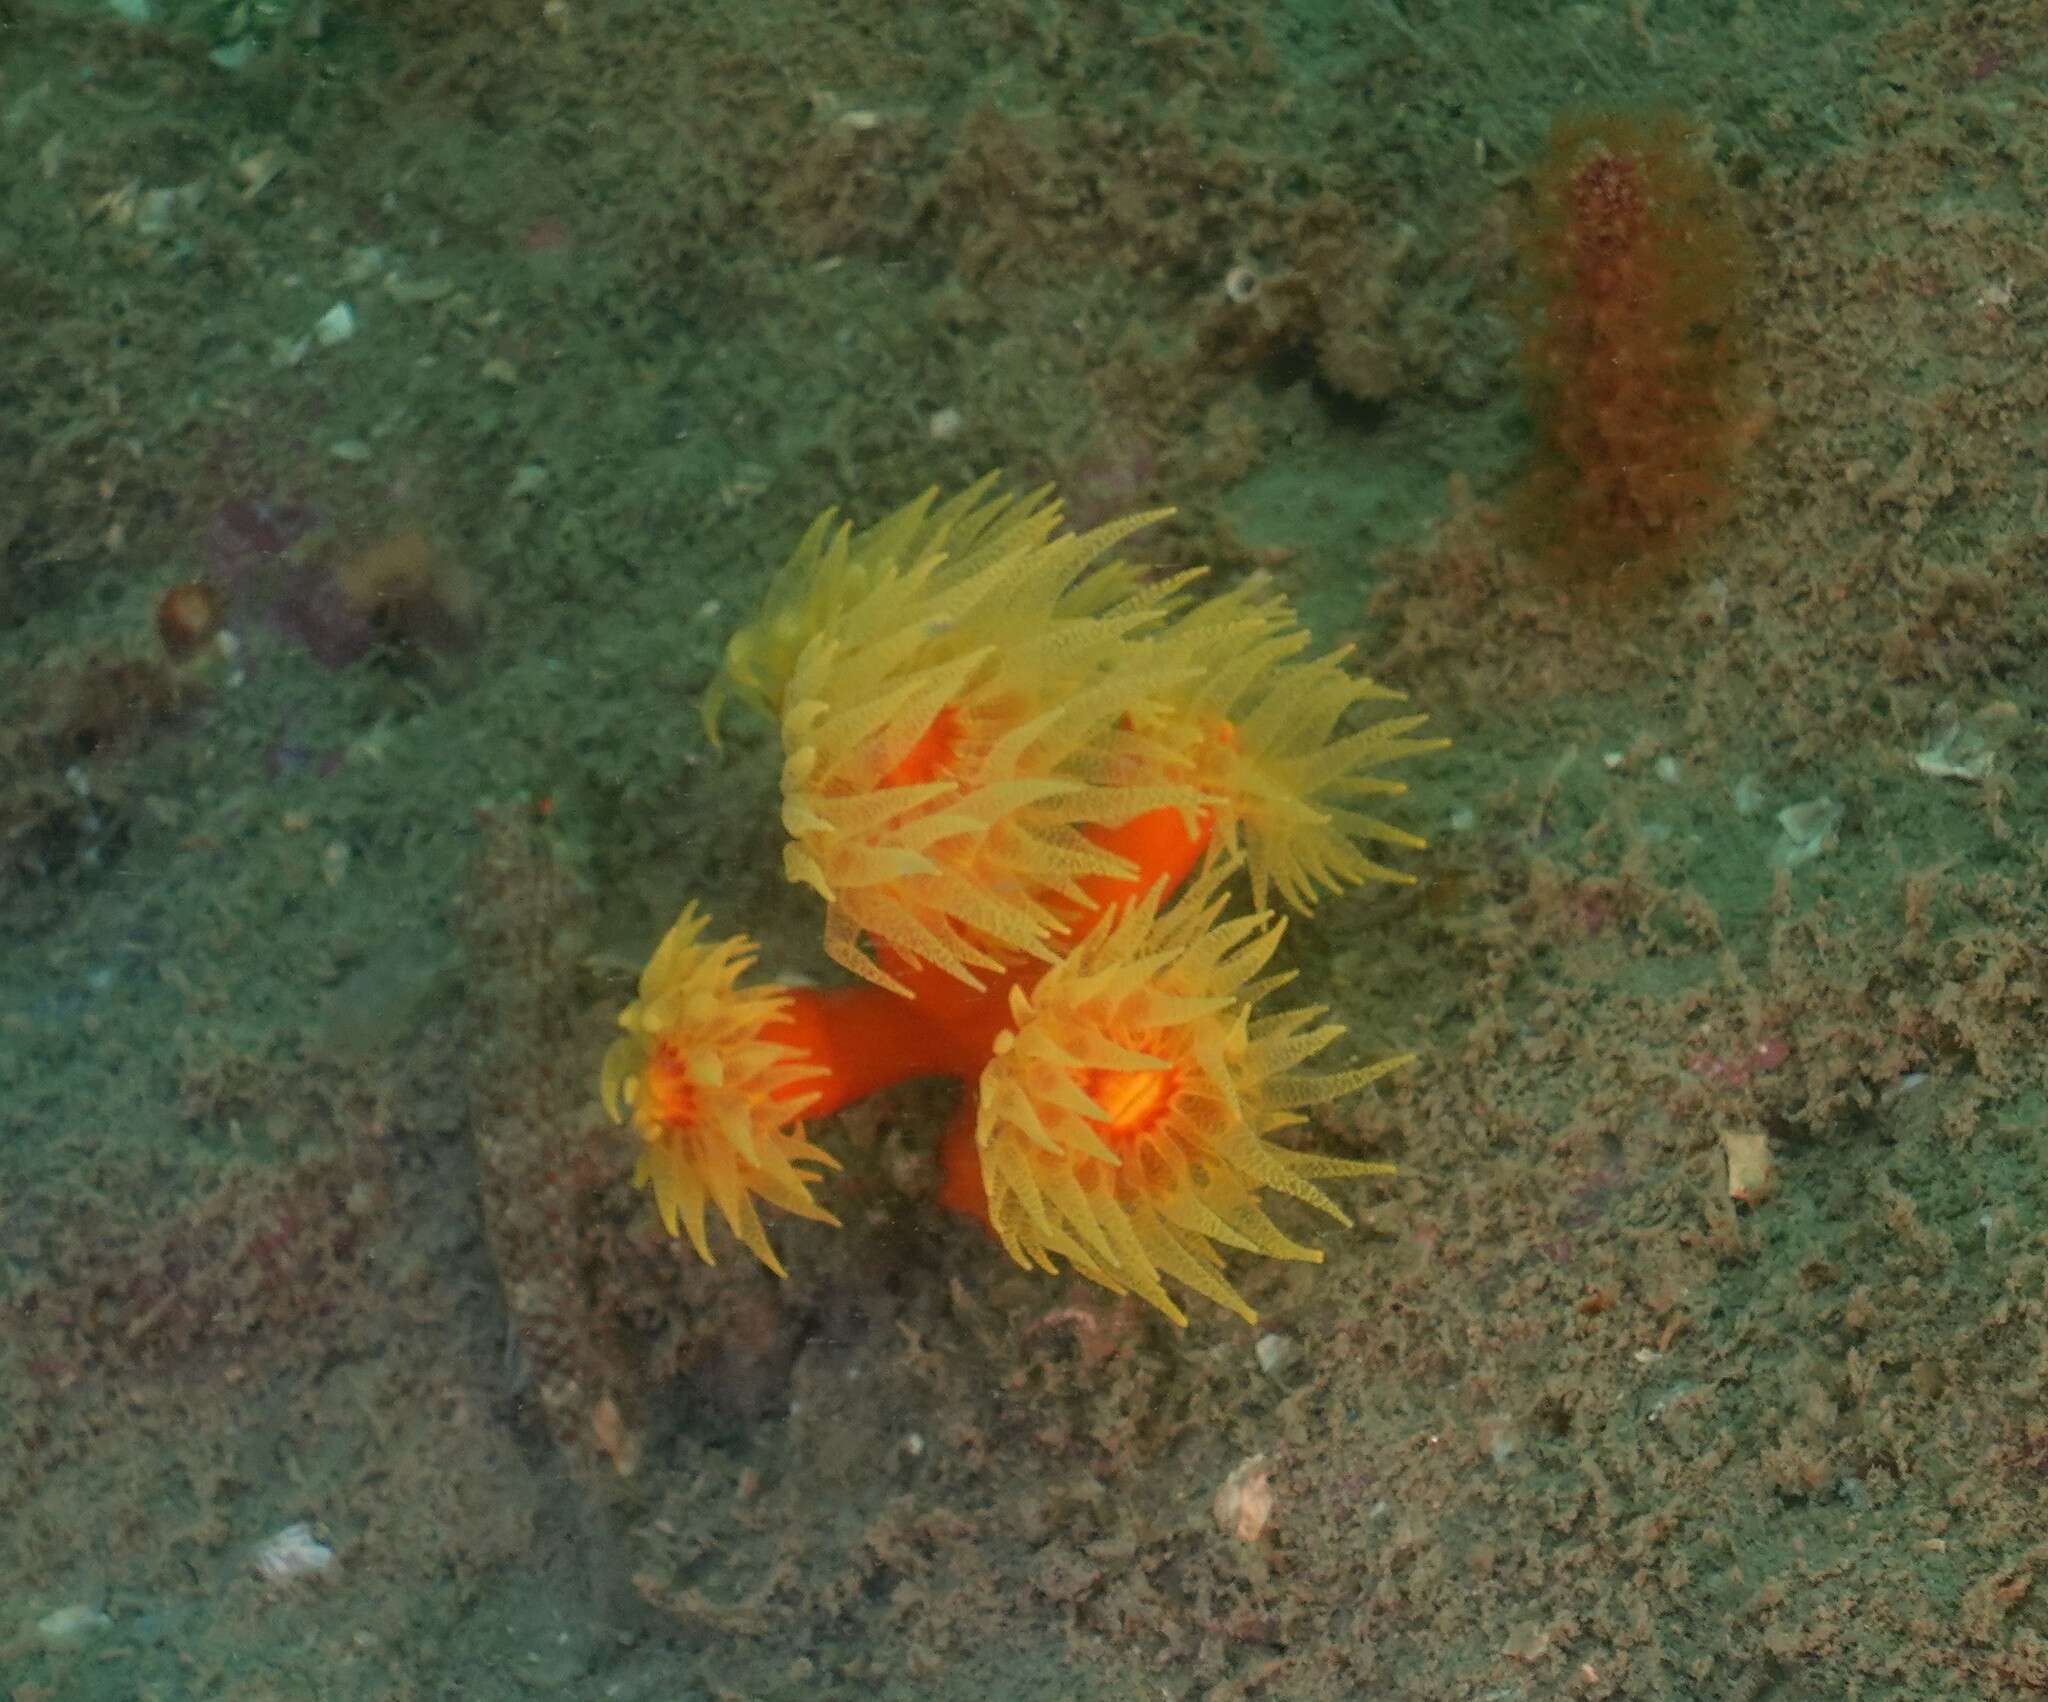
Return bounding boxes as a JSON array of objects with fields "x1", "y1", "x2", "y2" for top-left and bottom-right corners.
[{"x1": 1511, "y1": 115, "x2": 1761, "y2": 592}]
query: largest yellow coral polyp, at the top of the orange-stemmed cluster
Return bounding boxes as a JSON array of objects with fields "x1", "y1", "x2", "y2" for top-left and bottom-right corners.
[{"x1": 762, "y1": 485, "x2": 1200, "y2": 991}]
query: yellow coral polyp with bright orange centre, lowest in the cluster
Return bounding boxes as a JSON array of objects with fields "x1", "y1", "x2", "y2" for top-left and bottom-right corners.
[{"x1": 975, "y1": 860, "x2": 1409, "y2": 1325}]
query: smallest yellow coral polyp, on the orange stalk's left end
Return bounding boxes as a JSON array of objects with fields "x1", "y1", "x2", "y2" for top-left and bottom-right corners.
[{"x1": 602, "y1": 903, "x2": 838, "y2": 1276}]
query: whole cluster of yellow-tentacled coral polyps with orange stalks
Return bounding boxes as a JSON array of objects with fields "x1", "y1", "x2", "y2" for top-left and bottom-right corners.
[{"x1": 602, "y1": 475, "x2": 1444, "y2": 1323}]
